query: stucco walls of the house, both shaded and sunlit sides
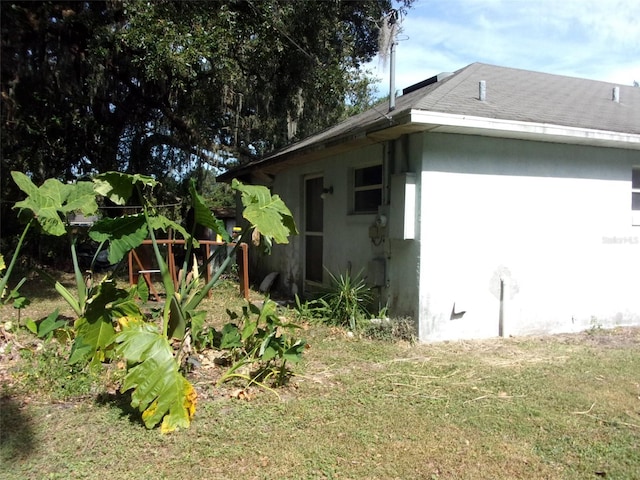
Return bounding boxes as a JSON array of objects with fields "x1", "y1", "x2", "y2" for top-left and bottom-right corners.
[{"x1": 249, "y1": 133, "x2": 640, "y2": 341}]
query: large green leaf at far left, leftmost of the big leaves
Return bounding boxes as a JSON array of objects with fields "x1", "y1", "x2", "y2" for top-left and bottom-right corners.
[{"x1": 11, "y1": 172, "x2": 98, "y2": 236}]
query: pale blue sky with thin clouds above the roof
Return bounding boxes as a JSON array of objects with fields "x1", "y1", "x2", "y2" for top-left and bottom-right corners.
[{"x1": 367, "y1": 0, "x2": 640, "y2": 96}]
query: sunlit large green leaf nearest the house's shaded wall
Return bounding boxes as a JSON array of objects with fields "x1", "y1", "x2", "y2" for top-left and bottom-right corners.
[{"x1": 231, "y1": 179, "x2": 298, "y2": 243}]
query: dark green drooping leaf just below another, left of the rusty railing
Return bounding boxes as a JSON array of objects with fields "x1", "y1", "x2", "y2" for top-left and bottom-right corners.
[{"x1": 89, "y1": 214, "x2": 149, "y2": 264}]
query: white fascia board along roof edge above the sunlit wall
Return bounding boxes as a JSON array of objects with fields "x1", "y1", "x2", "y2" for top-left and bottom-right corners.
[{"x1": 407, "y1": 110, "x2": 640, "y2": 150}]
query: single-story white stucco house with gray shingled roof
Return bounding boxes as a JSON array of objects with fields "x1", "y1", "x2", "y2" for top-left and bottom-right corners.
[{"x1": 223, "y1": 63, "x2": 640, "y2": 341}]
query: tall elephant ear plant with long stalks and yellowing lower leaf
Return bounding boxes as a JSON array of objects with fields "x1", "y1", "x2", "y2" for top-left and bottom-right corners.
[{"x1": 90, "y1": 173, "x2": 297, "y2": 432}]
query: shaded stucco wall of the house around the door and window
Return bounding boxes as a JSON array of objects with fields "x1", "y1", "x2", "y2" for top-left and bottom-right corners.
[{"x1": 254, "y1": 135, "x2": 422, "y2": 319}]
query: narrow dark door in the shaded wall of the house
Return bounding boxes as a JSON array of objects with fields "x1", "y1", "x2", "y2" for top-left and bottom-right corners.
[{"x1": 304, "y1": 177, "x2": 324, "y2": 284}]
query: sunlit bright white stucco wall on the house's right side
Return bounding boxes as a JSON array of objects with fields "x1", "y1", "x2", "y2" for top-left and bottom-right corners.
[{"x1": 418, "y1": 134, "x2": 640, "y2": 341}]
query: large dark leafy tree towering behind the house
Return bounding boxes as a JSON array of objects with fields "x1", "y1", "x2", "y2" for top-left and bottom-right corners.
[{"x1": 0, "y1": 0, "x2": 413, "y2": 195}]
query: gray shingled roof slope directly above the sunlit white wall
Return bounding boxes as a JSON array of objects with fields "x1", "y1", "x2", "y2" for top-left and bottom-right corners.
[{"x1": 402, "y1": 63, "x2": 640, "y2": 134}]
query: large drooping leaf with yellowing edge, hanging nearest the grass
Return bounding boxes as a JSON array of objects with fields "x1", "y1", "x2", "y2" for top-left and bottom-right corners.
[{"x1": 116, "y1": 321, "x2": 196, "y2": 433}]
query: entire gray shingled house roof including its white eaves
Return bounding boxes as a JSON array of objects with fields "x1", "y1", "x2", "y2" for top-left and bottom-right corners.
[{"x1": 220, "y1": 63, "x2": 640, "y2": 180}]
